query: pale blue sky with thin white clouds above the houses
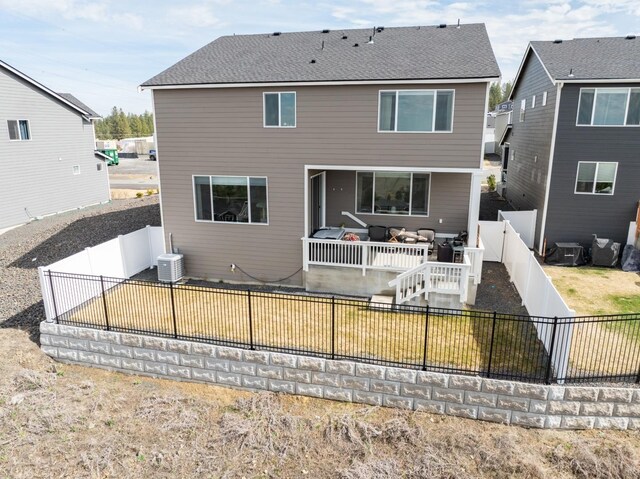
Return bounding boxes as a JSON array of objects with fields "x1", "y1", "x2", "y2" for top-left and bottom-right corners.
[{"x1": 0, "y1": 0, "x2": 640, "y2": 114}]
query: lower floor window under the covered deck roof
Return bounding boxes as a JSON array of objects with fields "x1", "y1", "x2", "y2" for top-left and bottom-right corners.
[{"x1": 356, "y1": 171, "x2": 431, "y2": 216}]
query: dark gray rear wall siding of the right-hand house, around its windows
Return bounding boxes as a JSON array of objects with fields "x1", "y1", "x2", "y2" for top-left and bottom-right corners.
[{"x1": 545, "y1": 84, "x2": 640, "y2": 245}]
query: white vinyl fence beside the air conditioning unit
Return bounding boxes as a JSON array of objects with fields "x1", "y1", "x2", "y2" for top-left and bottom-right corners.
[{"x1": 38, "y1": 226, "x2": 165, "y2": 321}]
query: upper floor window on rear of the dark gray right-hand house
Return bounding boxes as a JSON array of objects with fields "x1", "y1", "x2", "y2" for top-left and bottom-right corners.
[{"x1": 577, "y1": 88, "x2": 640, "y2": 126}]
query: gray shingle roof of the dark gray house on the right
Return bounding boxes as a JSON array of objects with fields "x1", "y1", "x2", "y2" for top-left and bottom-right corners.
[{"x1": 531, "y1": 37, "x2": 640, "y2": 80}]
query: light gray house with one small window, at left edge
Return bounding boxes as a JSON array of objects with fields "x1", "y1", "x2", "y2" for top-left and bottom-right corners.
[{"x1": 0, "y1": 61, "x2": 110, "y2": 229}]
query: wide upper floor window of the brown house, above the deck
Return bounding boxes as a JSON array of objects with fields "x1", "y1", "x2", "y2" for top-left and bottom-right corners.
[{"x1": 378, "y1": 90, "x2": 453, "y2": 133}]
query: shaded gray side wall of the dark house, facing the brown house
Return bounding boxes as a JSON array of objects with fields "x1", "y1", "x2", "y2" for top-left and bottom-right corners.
[{"x1": 506, "y1": 52, "x2": 556, "y2": 248}]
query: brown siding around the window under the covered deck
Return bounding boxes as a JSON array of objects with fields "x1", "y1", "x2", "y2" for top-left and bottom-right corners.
[{"x1": 327, "y1": 171, "x2": 472, "y2": 233}]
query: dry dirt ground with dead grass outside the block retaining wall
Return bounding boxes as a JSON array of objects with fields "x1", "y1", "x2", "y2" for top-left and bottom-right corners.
[{"x1": 0, "y1": 201, "x2": 640, "y2": 479}]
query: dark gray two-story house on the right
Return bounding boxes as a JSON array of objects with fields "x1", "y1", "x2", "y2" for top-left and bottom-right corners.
[{"x1": 502, "y1": 35, "x2": 640, "y2": 251}]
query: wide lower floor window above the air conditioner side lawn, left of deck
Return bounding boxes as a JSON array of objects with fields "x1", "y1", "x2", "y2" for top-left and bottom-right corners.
[{"x1": 193, "y1": 176, "x2": 268, "y2": 224}]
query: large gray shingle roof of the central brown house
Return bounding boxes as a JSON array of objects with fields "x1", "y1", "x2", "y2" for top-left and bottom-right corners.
[{"x1": 142, "y1": 24, "x2": 500, "y2": 86}]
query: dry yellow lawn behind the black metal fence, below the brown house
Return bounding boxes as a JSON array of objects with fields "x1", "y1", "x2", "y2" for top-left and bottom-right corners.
[{"x1": 63, "y1": 282, "x2": 542, "y2": 380}]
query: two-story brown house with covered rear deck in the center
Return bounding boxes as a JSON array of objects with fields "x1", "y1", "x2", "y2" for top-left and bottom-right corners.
[{"x1": 142, "y1": 24, "x2": 500, "y2": 300}]
